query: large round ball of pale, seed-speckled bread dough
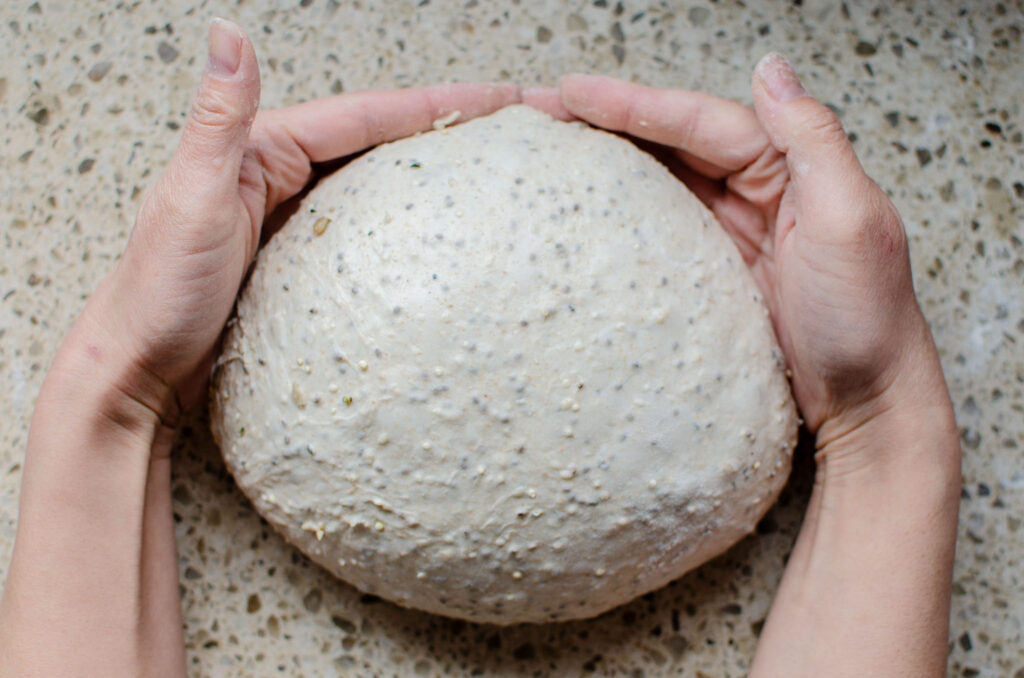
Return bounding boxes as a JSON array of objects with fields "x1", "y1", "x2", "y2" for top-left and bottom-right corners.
[{"x1": 212, "y1": 107, "x2": 797, "y2": 624}]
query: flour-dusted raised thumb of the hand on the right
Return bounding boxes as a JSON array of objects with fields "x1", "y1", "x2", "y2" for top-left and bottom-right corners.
[{"x1": 752, "y1": 52, "x2": 874, "y2": 218}]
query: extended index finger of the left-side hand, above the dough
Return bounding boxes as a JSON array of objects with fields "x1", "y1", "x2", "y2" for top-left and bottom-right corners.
[{"x1": 259, "y1": 83, "x2": 522, "y2": 163}]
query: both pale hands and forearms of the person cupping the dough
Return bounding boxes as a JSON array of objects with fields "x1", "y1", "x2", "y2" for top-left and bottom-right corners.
[{"x1": 0, "y1": 22, "x2": 959, "y2": 677}]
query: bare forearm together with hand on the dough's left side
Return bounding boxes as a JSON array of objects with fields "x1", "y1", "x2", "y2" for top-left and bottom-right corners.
[{"x1": 0, "y1": 20, "x2": 519, "y2": 676}]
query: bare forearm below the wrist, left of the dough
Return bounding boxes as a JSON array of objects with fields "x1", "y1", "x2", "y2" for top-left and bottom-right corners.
[{"x1": 0, "y1": 288, "x2": 184, "y2": 676}]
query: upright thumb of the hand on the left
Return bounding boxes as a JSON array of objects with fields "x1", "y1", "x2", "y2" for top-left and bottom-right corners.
[{"x1": 169, "y1": 18, "x2": 259, "y2": 192}]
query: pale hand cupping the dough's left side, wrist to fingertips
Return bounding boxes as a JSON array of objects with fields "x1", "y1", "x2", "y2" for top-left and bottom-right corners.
[{"x1": 96, "y1": 19, "x2": 519, "y2": 421}]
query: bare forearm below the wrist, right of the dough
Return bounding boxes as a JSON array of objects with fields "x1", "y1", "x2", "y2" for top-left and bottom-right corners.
[{"x1": 752, "y1": 385, "x2": 959, "y2": 677}]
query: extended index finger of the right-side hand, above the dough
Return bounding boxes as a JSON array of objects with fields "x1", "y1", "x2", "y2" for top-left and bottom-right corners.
[{"x1": 559, "y1": 75, "x2": 768, "y2": 178}]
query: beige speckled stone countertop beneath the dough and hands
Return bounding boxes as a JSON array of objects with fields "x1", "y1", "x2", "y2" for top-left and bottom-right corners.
[{"x1": 0, "y1": 0, "x2": 1024, "y2": 678}]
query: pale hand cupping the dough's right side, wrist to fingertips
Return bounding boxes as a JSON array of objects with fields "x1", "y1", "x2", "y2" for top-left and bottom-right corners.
[{"x1": 544, "y1": 54, "x2": 948, "y2": 456}]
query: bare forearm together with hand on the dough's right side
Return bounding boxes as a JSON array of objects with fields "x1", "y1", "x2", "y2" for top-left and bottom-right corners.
[{"x1": 552, "y1": 55, "x2": 959, "y2": 678}]
